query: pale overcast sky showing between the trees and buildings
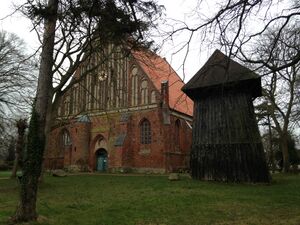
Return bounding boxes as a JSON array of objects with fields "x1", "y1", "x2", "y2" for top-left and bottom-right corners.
[{"x1": 0, "y1": 0, "x2": 296, "y2": 82}]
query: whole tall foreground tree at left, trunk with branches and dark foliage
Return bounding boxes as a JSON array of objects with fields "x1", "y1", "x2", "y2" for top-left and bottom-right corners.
[{"x1": 13, "y1": 0, "x2": 160, "y2": 221}]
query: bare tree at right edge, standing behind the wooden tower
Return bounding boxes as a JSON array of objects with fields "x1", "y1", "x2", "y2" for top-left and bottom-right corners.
[{"x1": 256, "y1": 28, "x2": 300, "y2": 172}]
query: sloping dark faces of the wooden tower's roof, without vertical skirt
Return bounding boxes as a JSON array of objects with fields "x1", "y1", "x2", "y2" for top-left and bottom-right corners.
[{"x1": 182, "y1": 50, "x2": 258, "y2": 93}]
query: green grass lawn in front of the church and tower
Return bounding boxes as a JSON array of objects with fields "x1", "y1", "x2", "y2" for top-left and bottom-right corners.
[{"x1": 0, "y1": 171, "x2": 300, "y2": 225}]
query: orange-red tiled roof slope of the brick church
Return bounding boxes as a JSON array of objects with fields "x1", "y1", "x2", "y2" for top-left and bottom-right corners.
[{"x1": 132, "y1": 51, "x2": 193, "y2": 116}]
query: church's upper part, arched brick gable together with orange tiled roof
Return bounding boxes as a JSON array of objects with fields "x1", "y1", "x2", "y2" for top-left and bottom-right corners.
[{"x1": 57, "y1": 45, "x2": 193, "y2": 117}]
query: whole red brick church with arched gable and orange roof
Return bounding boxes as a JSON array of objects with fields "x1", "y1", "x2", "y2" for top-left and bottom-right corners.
[{"x1": 44, "y1": 45, "x2": 193, "y2": 173}]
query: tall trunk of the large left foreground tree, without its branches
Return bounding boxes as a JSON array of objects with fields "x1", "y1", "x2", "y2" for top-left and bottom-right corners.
[{"x1": 12, "y1": 0, "x2": 58, "y2": 222}]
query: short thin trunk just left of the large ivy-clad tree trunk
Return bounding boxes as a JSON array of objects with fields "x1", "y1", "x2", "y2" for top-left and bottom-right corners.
[{"x1": 10, "y1": 119, "x2": 27, "y2": 178}]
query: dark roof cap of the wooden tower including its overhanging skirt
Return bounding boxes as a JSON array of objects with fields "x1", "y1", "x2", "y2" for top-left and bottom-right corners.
[{"x1": 182, "y1": 50, "x2": 261, "y2": 98}]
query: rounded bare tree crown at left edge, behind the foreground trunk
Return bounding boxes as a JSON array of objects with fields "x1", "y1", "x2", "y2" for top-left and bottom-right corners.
[{"x1": 0, "y1": 31, "x2": 36, "y2": 119}]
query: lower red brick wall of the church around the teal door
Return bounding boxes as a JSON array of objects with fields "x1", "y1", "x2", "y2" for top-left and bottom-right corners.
[{"x1": 46, "y1": 108, "x2": 191, "y2": 171}]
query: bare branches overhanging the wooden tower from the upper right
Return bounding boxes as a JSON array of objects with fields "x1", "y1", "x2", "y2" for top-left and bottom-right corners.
[{"x1": 164, "y1": 0, "x2": 300, "y2": 76}]
